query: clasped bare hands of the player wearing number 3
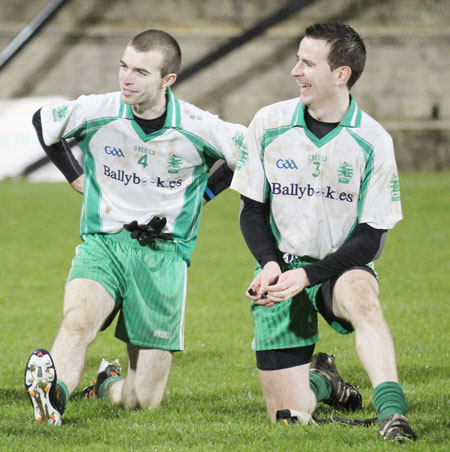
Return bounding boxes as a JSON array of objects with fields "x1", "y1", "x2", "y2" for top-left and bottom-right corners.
[{"x1": 247, "y1": 261, "x2": 309, "y2": 307}]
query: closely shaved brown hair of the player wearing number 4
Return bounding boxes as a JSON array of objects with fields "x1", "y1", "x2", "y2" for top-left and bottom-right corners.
[{"x1": 129, "y1": 29, "x2": 181, "y2": 77}]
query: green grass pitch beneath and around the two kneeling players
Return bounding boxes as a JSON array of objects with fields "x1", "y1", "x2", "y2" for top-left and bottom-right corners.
[{"x1": 0, "y1": 173, "x2": 450, "y2": 452}]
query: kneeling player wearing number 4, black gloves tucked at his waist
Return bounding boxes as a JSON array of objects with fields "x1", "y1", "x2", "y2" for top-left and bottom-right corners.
[{"x1": 25, "y1": 30, "x2": 246, "y2": 424}]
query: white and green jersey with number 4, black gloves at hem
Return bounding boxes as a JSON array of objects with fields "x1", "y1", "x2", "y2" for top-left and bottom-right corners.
[{"x1": 41, "y1": 89, "x2": 246, "y2": 260}]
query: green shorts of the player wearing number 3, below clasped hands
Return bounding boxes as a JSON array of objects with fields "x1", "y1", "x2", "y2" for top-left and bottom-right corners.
[{"x1": 251, "y1": 256, "x2": 368, "y2": 351}]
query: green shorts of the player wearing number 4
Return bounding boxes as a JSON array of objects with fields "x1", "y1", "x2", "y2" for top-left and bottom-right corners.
[{"x1": 67, "y1": 231, "x2": 187, "y2": 351}]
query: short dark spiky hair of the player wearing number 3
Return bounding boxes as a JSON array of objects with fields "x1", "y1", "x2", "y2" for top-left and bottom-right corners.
[{"x1": 305, "y1": 23, "x2": 367, "y2": 89}]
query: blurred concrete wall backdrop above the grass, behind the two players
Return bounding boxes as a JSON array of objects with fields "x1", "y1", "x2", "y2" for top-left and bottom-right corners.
[{"x1": 0, "y1": 0, "x2": 450, "y2": 180}]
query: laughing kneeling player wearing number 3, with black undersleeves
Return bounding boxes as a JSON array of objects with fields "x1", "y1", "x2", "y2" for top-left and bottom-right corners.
[{"x1": 231, "y1": 24, "x2": 415, "y2": 441}]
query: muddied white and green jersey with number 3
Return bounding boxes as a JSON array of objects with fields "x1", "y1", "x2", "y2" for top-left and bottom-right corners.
[{"x1": 231, "y1": 94, "x2": 402, "y2": 259}]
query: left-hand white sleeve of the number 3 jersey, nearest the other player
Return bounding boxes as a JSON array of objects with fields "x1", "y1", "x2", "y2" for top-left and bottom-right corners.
[{"x1": 231, "y1": 111, "x2": 268, "y2": 202}]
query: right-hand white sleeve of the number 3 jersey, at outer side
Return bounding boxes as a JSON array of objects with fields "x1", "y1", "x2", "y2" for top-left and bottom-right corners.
[{"x1": 359, "y1": 133, "x2": 402, "y2": 229}]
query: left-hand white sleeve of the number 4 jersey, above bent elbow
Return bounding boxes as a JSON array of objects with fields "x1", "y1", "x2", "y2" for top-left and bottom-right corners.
[{"x1": 41, "y1": 99, "x2": 86, "y2": 146}]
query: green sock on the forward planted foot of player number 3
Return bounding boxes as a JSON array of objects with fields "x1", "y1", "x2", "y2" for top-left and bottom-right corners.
[{"x1": 372, "y1": 381, "x2": 406, "y2": 421}]
